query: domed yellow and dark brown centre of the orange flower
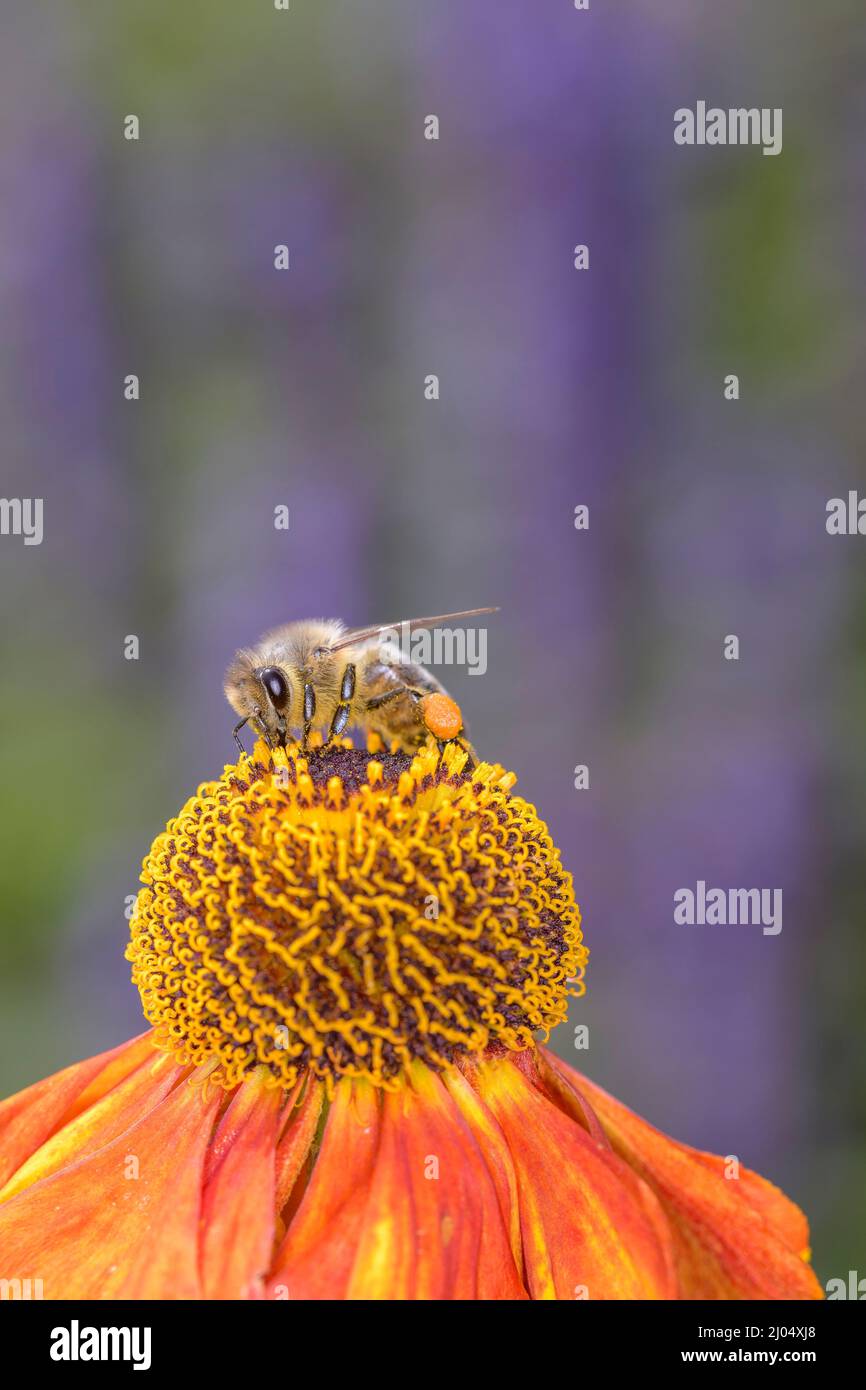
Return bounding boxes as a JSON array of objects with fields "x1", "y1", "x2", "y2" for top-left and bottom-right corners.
[{"x1": 126, "y1": 741, "x2": 588, "y2": 1087}]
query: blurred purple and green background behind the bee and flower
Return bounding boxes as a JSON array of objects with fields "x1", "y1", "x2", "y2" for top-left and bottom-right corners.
[{"x1": 0, "y1": 0, "x2": 866, "y2": 1279}]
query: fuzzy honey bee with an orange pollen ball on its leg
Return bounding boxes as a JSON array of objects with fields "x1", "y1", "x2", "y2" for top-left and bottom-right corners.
[{"x1": 224, "y1": 607, "x2": 498, "y2": 755}]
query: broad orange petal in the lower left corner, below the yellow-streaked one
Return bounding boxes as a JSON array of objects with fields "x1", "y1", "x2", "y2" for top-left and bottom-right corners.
[{"x1": 0, "y1": 1083, "x2": 220, "y2": 1298}]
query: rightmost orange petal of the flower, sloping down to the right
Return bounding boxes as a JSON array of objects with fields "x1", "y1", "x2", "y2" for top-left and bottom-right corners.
[{"x1": 541, "y1": 1048, "x2": 823, "y2": 1300}]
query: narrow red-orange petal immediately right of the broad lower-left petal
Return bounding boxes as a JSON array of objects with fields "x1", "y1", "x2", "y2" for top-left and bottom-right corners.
[{"x1": 202, "y1": 1074, "x2": 282, "y2": 1298}]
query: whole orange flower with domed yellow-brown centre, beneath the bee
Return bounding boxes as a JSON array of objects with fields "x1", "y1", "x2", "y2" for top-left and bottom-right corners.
[{"x1": 0, "y1": 741, "x2": 820, "y2": 1300}]
